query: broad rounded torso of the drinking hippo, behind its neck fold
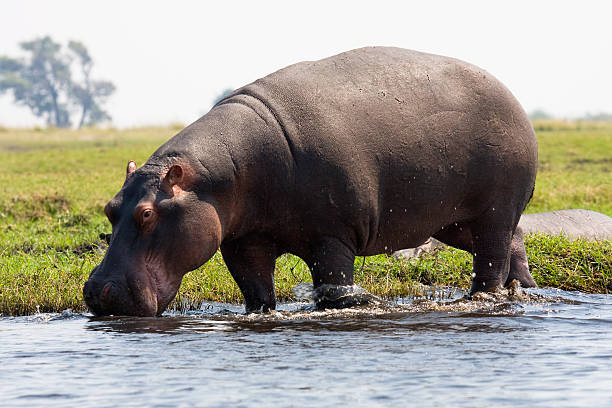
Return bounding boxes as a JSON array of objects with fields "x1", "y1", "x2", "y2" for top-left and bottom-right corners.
[{"x1": 219, "y1": 47, "x2": 537, "y2": 254}]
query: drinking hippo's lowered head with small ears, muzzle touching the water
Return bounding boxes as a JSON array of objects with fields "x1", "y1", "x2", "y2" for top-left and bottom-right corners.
[{"x1": 83, "y1": 161, "x2": 221, "y2": 316}]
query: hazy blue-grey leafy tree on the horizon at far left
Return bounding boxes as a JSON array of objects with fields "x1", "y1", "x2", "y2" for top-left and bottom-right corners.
[{"x1": 0, "y1": 36, "x2": 115, "y2": 127}]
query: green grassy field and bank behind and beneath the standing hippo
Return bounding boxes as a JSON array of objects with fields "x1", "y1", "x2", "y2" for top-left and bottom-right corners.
[{"x1": 0, "y1": 123, "x2": 612, "y2": 315}]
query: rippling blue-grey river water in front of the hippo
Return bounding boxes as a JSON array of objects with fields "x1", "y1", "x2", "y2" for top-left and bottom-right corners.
[{"x1": 0, "y1": 290, "x2": 612, "y2": 407}]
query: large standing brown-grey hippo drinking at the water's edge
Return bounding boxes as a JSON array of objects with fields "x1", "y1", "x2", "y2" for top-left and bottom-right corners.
[{"x1": 83, "y1": 47, "x2": 537, "y2": 316}]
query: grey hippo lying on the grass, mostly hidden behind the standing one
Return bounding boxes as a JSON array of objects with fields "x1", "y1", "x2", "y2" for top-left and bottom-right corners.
[{"x1": 393, "y1": 209, "x2": 612, "y2": 258}]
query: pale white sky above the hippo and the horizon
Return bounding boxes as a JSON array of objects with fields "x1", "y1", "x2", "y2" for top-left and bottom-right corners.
[{"x1": 0, "y1": 0, "x2": 612, "y2": 127}]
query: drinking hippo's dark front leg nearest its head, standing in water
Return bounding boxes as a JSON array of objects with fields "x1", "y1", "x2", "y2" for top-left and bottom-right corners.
[{"x1": 221, "y1": 237, "x2": 276, "y2": 313}]
